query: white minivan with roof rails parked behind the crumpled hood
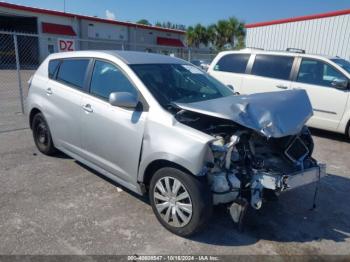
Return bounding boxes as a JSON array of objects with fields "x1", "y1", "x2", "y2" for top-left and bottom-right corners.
[{"x1": 208, "y1": 49, "x2": 350, "y2": 137}]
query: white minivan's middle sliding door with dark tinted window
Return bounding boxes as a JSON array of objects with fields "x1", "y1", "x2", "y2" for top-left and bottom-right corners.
[{"x1": 241, "y1": 54, "x2": 294, "y2": 94}]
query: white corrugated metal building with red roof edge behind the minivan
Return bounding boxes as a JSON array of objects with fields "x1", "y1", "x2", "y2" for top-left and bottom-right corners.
[{"x1": 246, "y1": 9, "x2": 350, "y2": 59}]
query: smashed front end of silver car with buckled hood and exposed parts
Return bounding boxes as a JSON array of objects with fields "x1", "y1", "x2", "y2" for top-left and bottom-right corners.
[{"x1": 176, "y1": 89, "x2": 326, "y2": 222}]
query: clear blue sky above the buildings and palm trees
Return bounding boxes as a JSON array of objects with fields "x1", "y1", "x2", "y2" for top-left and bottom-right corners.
[{"x1": 6, "y1": 0, "x2": 350, "y2": 26}]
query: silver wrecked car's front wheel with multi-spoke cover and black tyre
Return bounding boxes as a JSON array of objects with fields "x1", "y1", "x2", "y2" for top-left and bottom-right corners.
[{"x1": 149, "y1": 167, "x2": 212, "y2": 236}]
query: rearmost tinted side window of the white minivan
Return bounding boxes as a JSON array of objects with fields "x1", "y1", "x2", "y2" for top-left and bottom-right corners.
[{"x1": 214, "y1": 54, "x2": 250, "y2": 74}]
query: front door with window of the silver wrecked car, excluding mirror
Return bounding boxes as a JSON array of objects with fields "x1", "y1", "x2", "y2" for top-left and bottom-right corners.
[{"x1": 82, "y1": 60, "x2": 147, "y2": 183}]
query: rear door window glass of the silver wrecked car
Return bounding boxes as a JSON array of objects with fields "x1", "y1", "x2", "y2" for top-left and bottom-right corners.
[{"x1": 57, "y1": 59, "x2": 89, "y2": 89}]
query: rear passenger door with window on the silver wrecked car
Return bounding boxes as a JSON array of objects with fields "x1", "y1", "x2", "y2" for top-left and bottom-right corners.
[{"x1": 45, "y1": 58, "x2": 91, "y2": 153}]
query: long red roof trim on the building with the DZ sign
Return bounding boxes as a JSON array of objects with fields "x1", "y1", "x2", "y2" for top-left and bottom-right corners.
[{"x1": 0, "y1": 2, "x2": 186, "y2": 34}]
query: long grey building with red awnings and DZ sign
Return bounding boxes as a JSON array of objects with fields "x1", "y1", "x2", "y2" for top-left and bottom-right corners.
[{"x1": 0, "y1": 2, "x2": 185, "y2": 64}]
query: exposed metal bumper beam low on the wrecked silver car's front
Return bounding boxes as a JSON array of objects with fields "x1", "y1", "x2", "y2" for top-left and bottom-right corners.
[{"x1": 251, "y1": 164, "x2": 327, "y2": 209}]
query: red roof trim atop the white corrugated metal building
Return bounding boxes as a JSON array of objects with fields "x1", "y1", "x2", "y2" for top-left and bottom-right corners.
[{"x1": 245, "y1": 9, "x2": 350, "y2": 28}]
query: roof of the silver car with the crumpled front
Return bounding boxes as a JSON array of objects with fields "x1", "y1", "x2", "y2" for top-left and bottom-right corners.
[{"x1": 50, "y1": 50, "x2": 189, "y2": 65}]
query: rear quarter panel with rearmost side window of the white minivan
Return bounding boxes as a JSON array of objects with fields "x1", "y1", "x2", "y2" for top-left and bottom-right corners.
[{"x1": 210, "y1": 53, "x2": 250, "y2": 92}]
